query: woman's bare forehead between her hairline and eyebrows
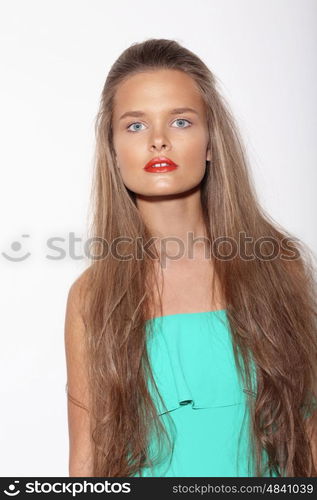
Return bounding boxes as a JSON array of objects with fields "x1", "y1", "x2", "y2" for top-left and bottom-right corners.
[{"x1": 114, "y1": 69, "x2": 204, "y2": 118}]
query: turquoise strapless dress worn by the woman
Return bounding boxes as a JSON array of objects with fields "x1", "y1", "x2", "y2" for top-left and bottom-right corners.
[{"x1": 133, "y1": 309, "x2": 314, "y2": 477}]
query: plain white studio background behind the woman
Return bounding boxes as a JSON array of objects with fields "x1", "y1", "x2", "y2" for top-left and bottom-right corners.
[{"x1": 0, "y1": 0, "x2": 317, "y2": 477}]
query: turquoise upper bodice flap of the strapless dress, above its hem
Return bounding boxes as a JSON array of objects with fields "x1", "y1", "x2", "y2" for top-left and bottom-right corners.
[{"x1": 147, "y1": 309, "x2": 246, "y2": 415}]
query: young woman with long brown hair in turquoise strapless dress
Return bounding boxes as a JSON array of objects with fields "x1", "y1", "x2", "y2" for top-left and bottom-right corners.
[{"x1": 65, "y1": 39, "x2": 317, "y2": 477}]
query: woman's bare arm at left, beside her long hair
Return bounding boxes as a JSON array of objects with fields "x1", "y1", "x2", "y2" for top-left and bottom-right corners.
[{"x1": 65, "y1": 276, "x2": 93, "y2": 477}]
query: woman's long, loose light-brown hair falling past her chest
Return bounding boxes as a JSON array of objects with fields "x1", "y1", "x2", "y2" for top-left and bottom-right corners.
[{"x1": 72, "y1": 39, "x2": 317, "y2": 477}]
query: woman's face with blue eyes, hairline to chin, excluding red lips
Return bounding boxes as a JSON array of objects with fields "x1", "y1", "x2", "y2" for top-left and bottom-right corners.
[{"x1": 112, "y1": 69, "x2": 211, "y2": 196}]
